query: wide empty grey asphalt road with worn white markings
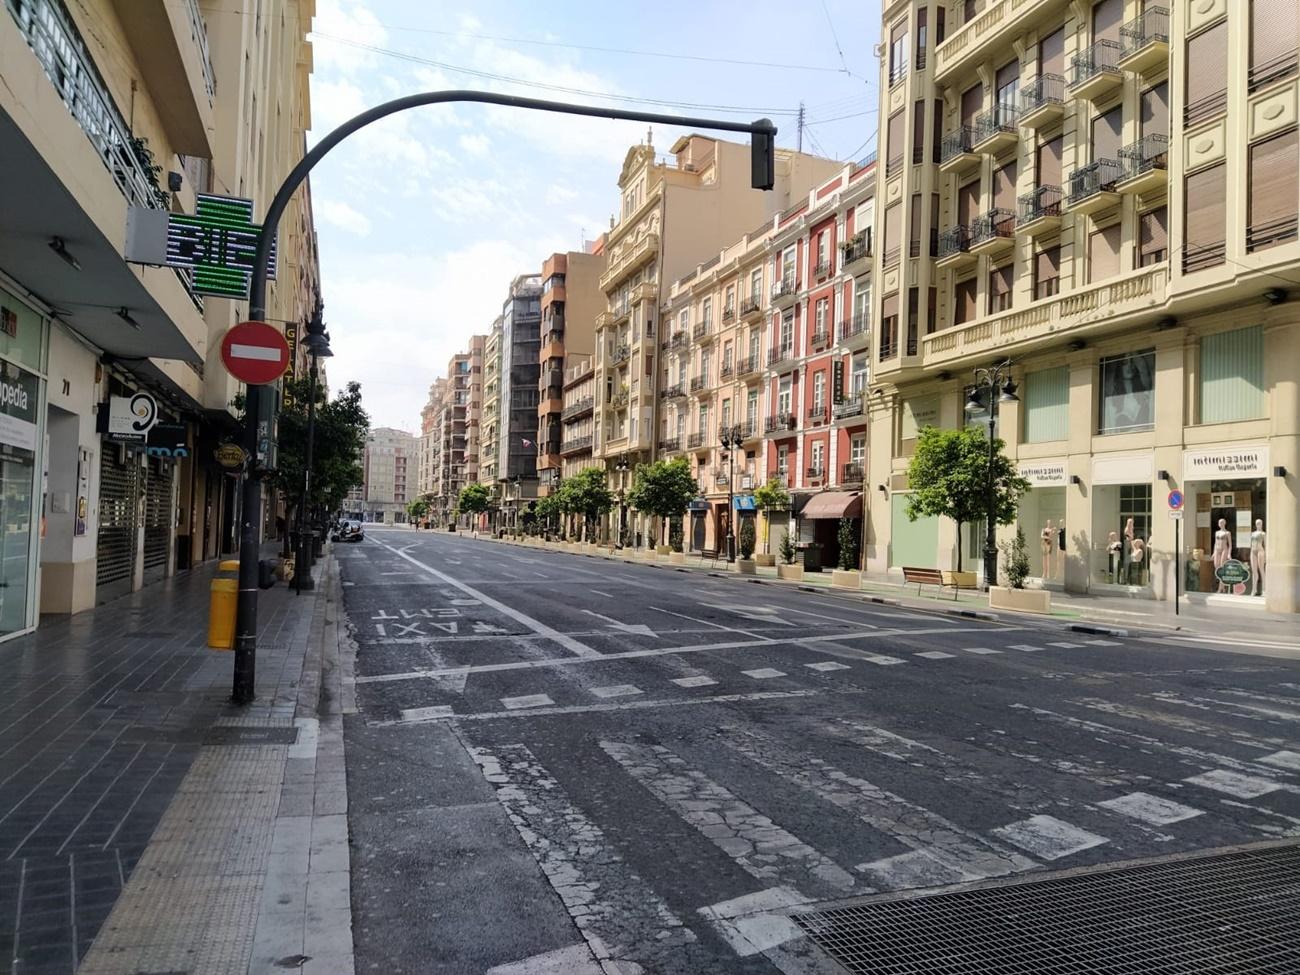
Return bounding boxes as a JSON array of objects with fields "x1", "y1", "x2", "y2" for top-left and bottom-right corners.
[{"x1": 337, "y1": 530, "x2": 1300, "y2": 975}]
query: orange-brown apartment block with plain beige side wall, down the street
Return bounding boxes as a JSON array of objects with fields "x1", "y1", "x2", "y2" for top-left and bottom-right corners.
[{"x1": 537, "y1": 249, "x2": 605, "y2": 495}]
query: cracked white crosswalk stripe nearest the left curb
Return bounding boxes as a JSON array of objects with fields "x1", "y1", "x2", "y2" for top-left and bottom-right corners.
[{"x1": 469, "y1": 745, "x2": 696, "y2": 972}]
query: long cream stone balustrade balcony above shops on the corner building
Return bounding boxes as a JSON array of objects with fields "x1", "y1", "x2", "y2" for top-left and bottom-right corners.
[{"x1": 920, "y1": 263, "x2": 1169, "y2": 369}]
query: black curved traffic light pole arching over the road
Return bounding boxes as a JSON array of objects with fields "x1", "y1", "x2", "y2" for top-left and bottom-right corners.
[{"x1": 231, "y1": 90, "x2": 776, "y2": 705}]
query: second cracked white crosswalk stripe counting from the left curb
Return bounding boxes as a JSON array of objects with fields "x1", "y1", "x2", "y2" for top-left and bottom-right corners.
[{"x1": 601, "y1": 741, "x2": 857, "y2": 897}]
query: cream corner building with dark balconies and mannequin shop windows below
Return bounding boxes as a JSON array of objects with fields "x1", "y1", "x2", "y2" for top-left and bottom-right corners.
[{"x1": 866, "y1": 0, "x2": 1300, "y2": 611}]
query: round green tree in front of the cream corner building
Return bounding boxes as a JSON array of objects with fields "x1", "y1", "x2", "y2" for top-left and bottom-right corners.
[{"x1": 907, "y1": 426, "x2": 1030, "y2": 572}]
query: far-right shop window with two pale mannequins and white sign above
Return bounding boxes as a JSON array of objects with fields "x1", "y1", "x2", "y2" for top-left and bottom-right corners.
[{"x1": 1182, "y1": 443, "x2": 1269, "y2": 607}]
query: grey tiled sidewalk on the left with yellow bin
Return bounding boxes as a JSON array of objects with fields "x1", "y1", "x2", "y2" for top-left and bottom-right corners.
[{"x1": 0, "y1": 551, "x2": 352, "y2": 975}]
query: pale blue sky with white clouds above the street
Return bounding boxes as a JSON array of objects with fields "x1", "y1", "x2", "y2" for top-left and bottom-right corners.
[{"x1": 309, "y1": 0, "x2": 880, "y2": 433}]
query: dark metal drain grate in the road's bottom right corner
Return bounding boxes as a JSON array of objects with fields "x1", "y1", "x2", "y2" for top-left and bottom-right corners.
[{"x1": 793, "y1": 842, "x2": 1300, "y2": 975}]
